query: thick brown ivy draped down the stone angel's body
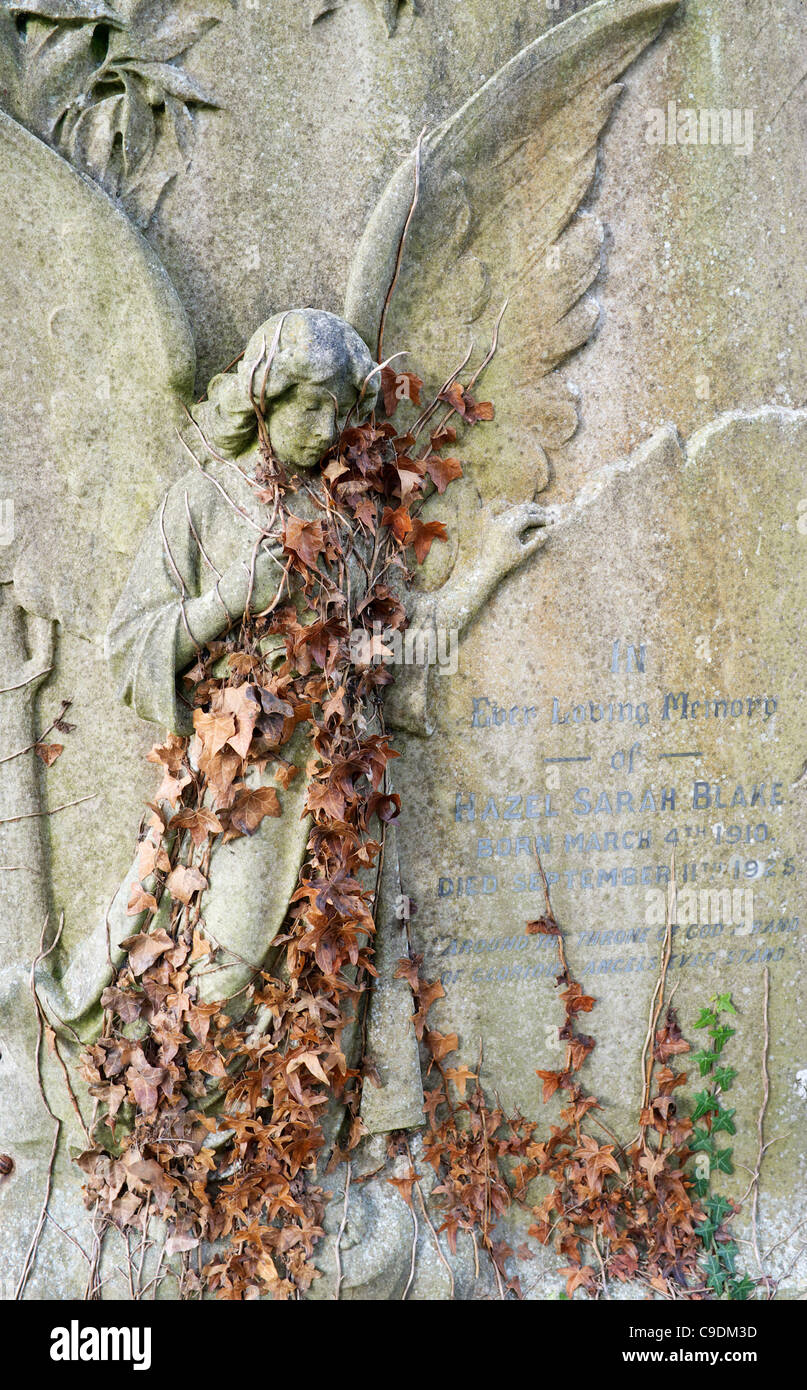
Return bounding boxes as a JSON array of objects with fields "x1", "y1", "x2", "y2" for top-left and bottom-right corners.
[{"x1": 79, "y1": 353, "x2": 492, "y2": 1298}]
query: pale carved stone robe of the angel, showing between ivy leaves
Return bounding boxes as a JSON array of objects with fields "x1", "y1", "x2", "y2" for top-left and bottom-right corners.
[{"x1": 107, "y1": 457, "x2": 433, "y2": 1130}]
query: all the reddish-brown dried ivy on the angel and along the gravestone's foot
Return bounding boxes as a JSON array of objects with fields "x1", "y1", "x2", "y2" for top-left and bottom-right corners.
[{"x1": 72, "y1": 347, "x2": 751, "y2": 1300}]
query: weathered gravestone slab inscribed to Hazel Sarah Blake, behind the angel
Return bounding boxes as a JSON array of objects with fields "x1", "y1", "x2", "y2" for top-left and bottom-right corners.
[{"x1": 0, "y1": 0, "x2": 807, "y2": 1300}]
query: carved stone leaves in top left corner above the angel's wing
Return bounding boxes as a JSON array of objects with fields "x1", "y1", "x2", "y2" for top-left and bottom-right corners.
[{"x1": 0, "y1": 0, "x2": 221, "y2": 227}]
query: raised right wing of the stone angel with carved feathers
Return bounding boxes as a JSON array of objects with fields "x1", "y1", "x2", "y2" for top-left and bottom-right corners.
[{"x1": 344, "y1": 0, "x2": 678, "y2": 500}]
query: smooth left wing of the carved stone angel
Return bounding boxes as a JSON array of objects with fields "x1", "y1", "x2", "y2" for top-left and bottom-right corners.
[{"x1": 0, "y1": 105, "x2": 194, "y2": 635}]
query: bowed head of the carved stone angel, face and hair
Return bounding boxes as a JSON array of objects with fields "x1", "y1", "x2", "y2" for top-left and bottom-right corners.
[{"x1": 201, "y1": 309, "x2": 379, "y2": 468}]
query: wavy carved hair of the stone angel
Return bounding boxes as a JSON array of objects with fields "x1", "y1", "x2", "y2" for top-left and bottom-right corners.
[{"x1": 206, "y1": 309, "x2": 378, "y2": 455}]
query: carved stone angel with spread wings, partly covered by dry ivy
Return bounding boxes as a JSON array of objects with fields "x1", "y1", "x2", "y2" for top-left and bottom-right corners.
[{"x1": 0, "y1": 0, "x2": 676, "y2": 1297}]
